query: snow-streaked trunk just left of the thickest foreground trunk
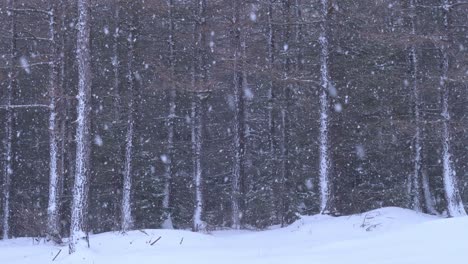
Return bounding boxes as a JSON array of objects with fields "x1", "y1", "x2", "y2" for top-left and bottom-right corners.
[{"x1": 47, "y1": 6, "x2": 63, "y2": 243}]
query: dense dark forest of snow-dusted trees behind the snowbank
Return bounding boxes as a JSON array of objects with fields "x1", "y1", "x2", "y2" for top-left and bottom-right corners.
[{"x1": 0, "y1": 0, "x2": 468, "y2": 252}]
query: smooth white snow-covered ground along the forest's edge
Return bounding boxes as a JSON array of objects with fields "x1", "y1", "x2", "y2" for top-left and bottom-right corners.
[{"x1": 0, "y1": 207, "x2": 468, "y2": 264}]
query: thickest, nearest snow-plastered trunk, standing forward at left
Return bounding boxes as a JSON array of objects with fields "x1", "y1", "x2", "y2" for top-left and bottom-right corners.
[{"x1": 69, "y1": 0, "x2": 91, "y2": 253}]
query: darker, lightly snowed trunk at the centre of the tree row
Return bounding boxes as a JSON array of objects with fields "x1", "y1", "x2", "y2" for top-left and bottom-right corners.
[{"x1": 231, "y1": 2, "x2": 245, "y2": 229}]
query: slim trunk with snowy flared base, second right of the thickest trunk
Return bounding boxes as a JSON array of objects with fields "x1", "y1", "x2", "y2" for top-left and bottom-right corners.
[{"x1": 162, "y1": 0, "x2": 177, "y2": 229}]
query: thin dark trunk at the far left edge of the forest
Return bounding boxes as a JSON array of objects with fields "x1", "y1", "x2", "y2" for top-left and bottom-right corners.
[{"x1": 2, "y1": 0, "x2": 17, "y2": 239}]
